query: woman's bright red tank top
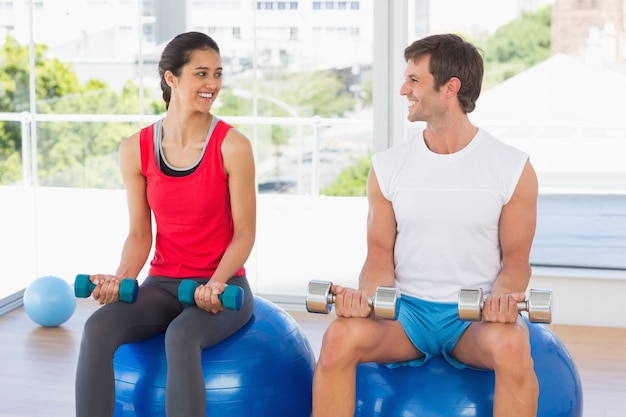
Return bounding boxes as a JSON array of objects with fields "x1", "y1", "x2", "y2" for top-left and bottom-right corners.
[{"x1": 140, "y1": 120, "x2": 245, "y2": 278}]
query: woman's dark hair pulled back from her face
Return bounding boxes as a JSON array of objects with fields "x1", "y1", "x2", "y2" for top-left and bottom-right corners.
[{"x1": 159, "y1": 32, "x2": 220, "y2": 109}]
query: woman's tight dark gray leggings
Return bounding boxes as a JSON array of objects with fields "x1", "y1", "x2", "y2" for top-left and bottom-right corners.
[{"x1": 76, "y1": 276, "x2": 254, "y2": 417}]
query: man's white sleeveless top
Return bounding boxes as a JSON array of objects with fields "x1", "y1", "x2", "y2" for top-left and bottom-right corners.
[{"x1": 372, "y1": 130, "x2": 528, "y2": 302}]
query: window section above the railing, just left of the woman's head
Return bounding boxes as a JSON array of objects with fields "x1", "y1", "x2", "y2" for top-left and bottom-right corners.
[{"x1": 33, "y1": 0, "x2": 151, "y2": 115}]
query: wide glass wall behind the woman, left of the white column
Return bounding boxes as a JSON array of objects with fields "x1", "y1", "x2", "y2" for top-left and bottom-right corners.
[{"x1": 0, "y1": 0, "x2": 373, "y2": 295}]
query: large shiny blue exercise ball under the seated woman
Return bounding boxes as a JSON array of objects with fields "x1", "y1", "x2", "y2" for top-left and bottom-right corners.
[{"x1": 113, "y1": 296, "x2": 315, "y2": 417}]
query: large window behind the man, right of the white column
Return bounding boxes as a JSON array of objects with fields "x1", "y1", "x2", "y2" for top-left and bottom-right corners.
[{"x1": 409, "y1": 0, "x2": 626, "y2": 270}]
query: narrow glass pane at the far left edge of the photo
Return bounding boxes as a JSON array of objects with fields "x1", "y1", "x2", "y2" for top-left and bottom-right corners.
[{"x1": 0, "y1": 8, "x2": 37, "y2": 300}]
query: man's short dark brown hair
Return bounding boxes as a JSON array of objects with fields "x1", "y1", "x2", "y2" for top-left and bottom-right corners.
[{"x1": 404, "y1": 34, "x2": 484, "y2": 113}]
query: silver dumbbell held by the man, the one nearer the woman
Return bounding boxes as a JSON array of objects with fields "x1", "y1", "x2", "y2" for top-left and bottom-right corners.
[{"x1": 306, "y1": 280, "x2": 400, "y2": 320}]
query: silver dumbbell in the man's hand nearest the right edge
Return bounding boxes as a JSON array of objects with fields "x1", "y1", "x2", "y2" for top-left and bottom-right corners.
[{"x1": 459, "y1": 288, "x2": 552, "y2": 323}]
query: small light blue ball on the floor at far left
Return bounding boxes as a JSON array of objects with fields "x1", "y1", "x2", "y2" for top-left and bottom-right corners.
[{"x1": 23, "y1": 276, "x2": 76, "y2": 327}]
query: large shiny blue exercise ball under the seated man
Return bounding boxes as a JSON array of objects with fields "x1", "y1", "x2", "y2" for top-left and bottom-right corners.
[{"x1": 355, "y1": 323, "x2": 583, "y2": 417}]
